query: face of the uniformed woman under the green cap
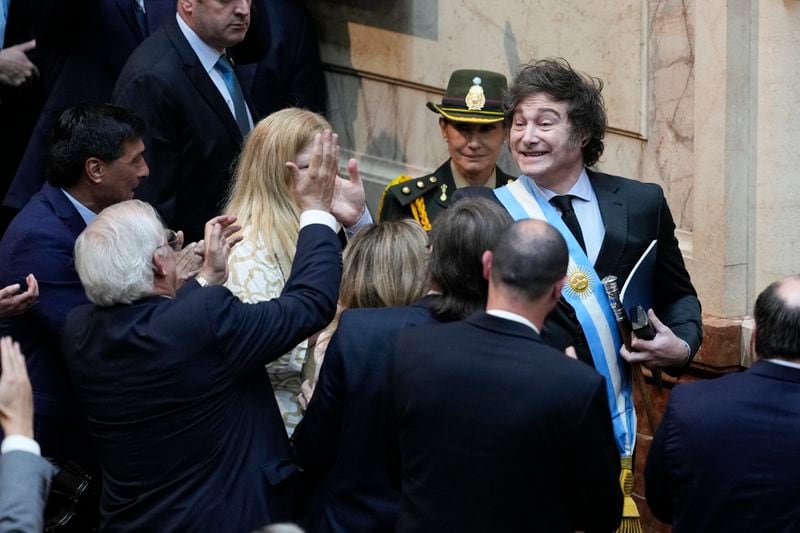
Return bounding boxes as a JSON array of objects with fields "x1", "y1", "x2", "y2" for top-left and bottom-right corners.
[{"x1": 439, "y1": 119, "x2": 507, "y2": 185}]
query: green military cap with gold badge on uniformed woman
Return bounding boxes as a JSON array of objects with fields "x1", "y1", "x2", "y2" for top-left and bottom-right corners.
[{"x1": 428, "y1": 70, "x2": 508, "y2": 124}]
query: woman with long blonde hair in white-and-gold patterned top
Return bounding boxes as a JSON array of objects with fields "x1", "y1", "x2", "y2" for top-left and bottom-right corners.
[{"x1": 224, "y1": 108, "x2": 372, "y2": 436}]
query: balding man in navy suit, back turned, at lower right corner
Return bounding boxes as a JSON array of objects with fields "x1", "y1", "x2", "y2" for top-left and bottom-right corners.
[{"x1": 645, "y1": 276, "x2": 800, "y2": 533}]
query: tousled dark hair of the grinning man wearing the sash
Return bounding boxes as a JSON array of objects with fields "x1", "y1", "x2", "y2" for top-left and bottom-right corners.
[{"x1": 503, "y1": 57, "x2": 608, "y2": 166}]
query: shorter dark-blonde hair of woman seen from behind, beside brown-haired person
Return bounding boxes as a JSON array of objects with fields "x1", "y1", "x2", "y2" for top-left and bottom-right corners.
[{"x1": 339, "y1": 219, "x2": 429, "y2": 309}]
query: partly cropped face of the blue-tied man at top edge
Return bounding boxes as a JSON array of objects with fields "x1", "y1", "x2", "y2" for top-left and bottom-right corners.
[{"x1": 179, "y1": 0, "x2": 251, "y2": 52}]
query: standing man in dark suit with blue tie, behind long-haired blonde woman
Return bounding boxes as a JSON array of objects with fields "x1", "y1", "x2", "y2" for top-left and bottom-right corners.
[{"x1": 113, "y1": 0, "x2": 266, "y2": 240}]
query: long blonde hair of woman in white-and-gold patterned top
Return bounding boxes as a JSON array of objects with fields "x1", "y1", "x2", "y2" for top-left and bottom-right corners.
[{"x1": 223, "y1": 108, "x2": 331, "y2": 265}]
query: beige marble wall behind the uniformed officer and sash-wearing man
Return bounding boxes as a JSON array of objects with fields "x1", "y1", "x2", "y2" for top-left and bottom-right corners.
[{"x1": 306, "y1": 0, "x2": 800, "y2": 318}]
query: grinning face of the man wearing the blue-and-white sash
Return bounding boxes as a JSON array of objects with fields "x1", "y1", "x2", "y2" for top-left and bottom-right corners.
[{"x1": 509, "y1": 93, "x2": 586, "y2": 194}]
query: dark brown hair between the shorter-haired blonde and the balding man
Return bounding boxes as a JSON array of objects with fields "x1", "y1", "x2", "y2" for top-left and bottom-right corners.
[{"x1": 430, "y1": 198, "x2": 512, "y2": 321}]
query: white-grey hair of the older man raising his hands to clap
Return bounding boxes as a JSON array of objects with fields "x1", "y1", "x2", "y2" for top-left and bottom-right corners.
[{"x1": 75, "y1": 200, "x2": 166, "y2": 307}]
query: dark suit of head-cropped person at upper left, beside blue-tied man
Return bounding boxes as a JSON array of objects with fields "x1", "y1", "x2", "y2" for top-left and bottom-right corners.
[{"x1": 3, "y1": 0, "x2": 175, "y2": 209}]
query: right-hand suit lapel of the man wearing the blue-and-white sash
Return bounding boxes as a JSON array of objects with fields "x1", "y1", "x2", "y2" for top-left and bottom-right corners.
[{"x1": 586, "y1": 170, "x2": 628, "y2": 277}]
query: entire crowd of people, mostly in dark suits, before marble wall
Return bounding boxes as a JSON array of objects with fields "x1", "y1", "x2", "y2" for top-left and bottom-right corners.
[{"x1": 0, "y1": 0, "x2": 800, "y2": 532}]
